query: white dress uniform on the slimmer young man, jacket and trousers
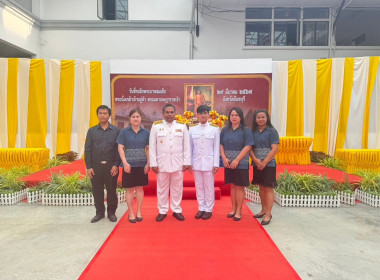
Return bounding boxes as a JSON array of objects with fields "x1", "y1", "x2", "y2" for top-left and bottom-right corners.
[{"x1": 189, "y1": 122, "x2": 220, "y2": 212}]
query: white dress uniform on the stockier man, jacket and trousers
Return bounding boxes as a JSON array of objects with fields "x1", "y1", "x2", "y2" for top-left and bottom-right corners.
[{"x1": 149, "y1": 120, "x2": 191, "y2": 214}]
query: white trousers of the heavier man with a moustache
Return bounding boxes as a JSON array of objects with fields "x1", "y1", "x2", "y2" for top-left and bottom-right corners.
[{"x1": 157, "y1": 171, "x2": 183, "y2": 214}]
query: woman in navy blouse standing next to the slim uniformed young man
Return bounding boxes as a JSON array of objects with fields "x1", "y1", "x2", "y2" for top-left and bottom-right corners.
[{"x1": 220, "y1": 107, "x2": 254, "y2": 221}]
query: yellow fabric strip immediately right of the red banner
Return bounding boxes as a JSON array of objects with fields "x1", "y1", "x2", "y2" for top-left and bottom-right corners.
[{"x1": 286, "y1": 60, "x2": 303, "y2": 136}]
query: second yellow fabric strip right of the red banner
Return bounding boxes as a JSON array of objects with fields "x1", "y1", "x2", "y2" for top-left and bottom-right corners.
[{"x1": 313, "y1": 59, "x2": 332, "y2": 154}]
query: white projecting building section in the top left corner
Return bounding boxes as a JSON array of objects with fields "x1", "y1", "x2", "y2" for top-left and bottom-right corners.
[{"x1": 0, "y1": 3, "x2": 40, "y2": 55}]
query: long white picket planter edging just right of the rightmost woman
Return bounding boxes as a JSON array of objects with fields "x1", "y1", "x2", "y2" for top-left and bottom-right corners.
[{"x1": 274, "y1": 191, "x2": 340, "y2": 207}]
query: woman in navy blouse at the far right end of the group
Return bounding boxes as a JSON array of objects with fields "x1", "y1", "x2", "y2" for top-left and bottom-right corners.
[{"x1": 250, "y1": 110, "x2": 280, "y2": 225}]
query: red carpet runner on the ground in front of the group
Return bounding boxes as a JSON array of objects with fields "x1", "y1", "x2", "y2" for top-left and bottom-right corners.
[{"x1": 79, "y1": 197, "x2": 300, "y2": 280}]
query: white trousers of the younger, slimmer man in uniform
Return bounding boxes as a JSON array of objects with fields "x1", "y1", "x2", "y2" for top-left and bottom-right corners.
[{"x1": 194, "y1": 170, "x2": 215, "y2": 212}]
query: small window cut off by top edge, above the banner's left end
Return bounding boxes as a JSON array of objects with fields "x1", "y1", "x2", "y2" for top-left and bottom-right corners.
[{"x1": 98, "y1": 0, "x2": 128, "y2": 20}]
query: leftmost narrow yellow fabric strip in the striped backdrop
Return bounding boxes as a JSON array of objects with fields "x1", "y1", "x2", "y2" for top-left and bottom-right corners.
[{"x1": 7, "y1": 58, "x2": 18, "y2": 148}]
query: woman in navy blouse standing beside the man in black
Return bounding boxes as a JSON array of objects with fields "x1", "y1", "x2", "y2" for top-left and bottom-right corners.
[{"x1": 116, "y1": 109, "x2": 149, "y2": 223}]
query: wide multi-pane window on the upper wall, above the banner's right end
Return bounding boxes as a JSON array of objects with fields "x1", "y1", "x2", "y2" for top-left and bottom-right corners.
[{"x1": 245, "y1": 8, "x2": 330, "y2": 46}]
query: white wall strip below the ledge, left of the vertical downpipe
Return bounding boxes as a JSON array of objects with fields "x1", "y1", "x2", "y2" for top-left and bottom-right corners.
[{"x1": 41, "y1": 30, "x2": 190, "y2": 60}]
